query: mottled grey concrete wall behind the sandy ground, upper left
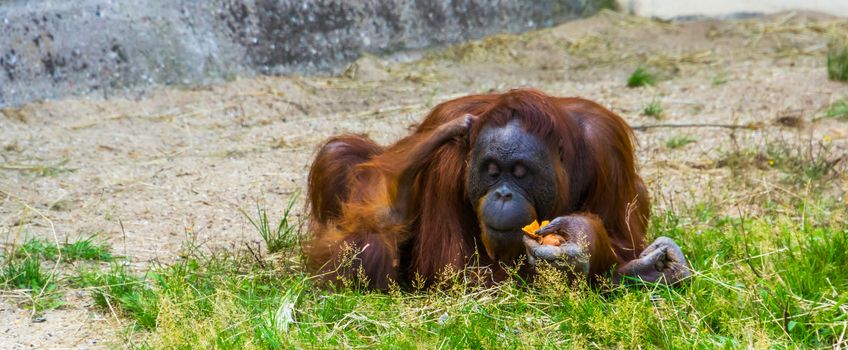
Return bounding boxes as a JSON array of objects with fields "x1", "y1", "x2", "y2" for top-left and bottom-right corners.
[{"x1": 0, "y1": 0, "x2": 609, "y2": 107}]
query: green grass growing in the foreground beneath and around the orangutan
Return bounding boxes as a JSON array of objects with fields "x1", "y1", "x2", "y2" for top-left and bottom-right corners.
[{"x1": 3, "y1": 180, "x2": 848, "y2": 349}]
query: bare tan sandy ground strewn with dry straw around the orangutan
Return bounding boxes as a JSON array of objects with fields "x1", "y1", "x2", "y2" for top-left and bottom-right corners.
[{"x1": 0, "y1": 9, "x2": 848, "y2": 349}]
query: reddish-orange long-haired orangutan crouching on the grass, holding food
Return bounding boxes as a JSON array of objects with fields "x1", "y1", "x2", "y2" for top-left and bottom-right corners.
[{"x1": 306, "y1": 89, "x2": 689, "y2": 289}]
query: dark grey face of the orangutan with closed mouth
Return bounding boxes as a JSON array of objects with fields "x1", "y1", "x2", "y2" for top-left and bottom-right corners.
[{"x1": 467, "y1": 120, "x2": 557, "y2": 261}]
